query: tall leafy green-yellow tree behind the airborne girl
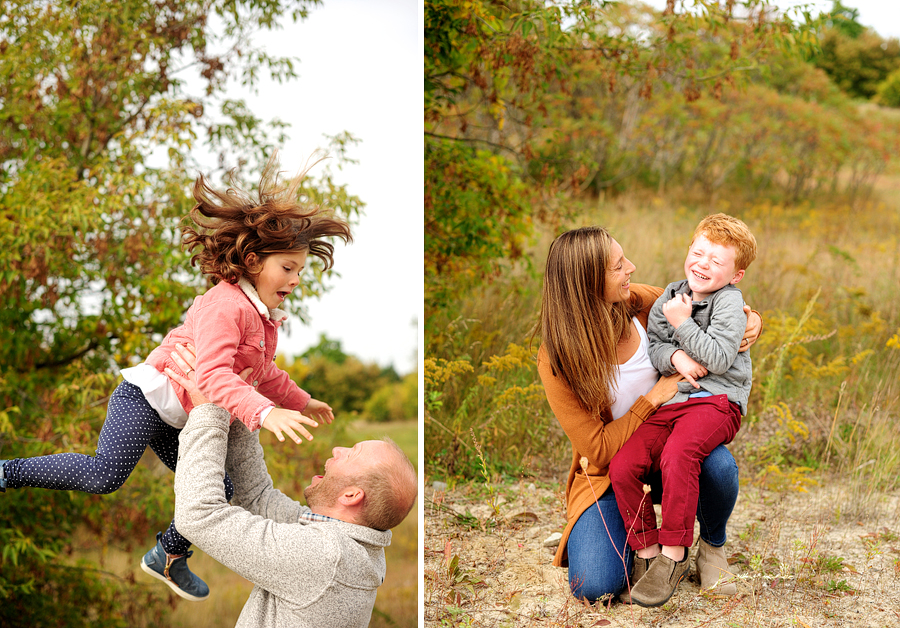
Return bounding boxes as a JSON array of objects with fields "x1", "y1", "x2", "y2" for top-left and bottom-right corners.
[{"x1": 0, "y1": 0, "x2": 361, "y2": 626}]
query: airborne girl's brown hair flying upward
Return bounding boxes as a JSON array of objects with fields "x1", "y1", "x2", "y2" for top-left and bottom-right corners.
[{"x1": 181, "y1": 156, "x2": 353, "y2": 284}]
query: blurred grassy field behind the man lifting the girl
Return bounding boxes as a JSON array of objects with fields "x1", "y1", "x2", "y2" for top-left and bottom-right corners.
[{"x1": 72, "y1": 421, "x2": 418, "y2": 628}]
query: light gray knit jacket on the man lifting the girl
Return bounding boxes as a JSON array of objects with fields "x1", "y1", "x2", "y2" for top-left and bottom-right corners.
[{"x1": 175, "y1": 404, "x2": 391, "y2": 628}]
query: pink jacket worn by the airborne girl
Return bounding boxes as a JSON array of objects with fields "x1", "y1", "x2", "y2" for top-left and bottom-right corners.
[{"x1": 146, "y1": 280, "x2": 310, "y2": 430}]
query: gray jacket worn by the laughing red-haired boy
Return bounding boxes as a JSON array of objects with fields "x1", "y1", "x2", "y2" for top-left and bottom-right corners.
[{"x1": 647, "y1": 279, "x2": 753, "y2": 415}]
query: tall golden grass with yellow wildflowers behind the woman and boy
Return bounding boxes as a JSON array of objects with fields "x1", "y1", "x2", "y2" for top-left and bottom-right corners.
[{"x1": 425, "y1": 177, "x2": 900, "y2": 480}]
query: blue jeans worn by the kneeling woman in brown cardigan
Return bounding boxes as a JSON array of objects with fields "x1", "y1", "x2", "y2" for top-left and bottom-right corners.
[{"x1": 567, "y1": 445, "x2": 739, "y2": 602}]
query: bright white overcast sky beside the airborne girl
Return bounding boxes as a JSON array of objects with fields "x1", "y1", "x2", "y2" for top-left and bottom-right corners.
[{"x1": 202, "y1": 0, "x2": 424, "y2": 374}]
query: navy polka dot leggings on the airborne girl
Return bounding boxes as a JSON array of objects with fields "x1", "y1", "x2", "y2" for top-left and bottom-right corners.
[{"x1": 3, "y1": 381, "x2": 234, "y2": 555}]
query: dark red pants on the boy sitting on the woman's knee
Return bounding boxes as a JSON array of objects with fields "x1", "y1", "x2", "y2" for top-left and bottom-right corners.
[{"x1": 609, "y1": 395, "x2": 741, "y2": 550}]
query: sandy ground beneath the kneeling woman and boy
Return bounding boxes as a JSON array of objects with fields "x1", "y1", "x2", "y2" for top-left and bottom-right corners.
[{"x1": 424, "y1": 480, "x2": 900, "y2": 628}]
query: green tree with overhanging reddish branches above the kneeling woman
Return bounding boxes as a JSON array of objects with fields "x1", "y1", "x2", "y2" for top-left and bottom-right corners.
[{"x1": 424, "y1": 0, "x2": 813, "y2": 324}]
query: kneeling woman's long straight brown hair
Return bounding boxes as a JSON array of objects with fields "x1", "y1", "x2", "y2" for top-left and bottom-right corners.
[{"x1": 539, "y1": 227, "x2": 640, "y2": 416}]
